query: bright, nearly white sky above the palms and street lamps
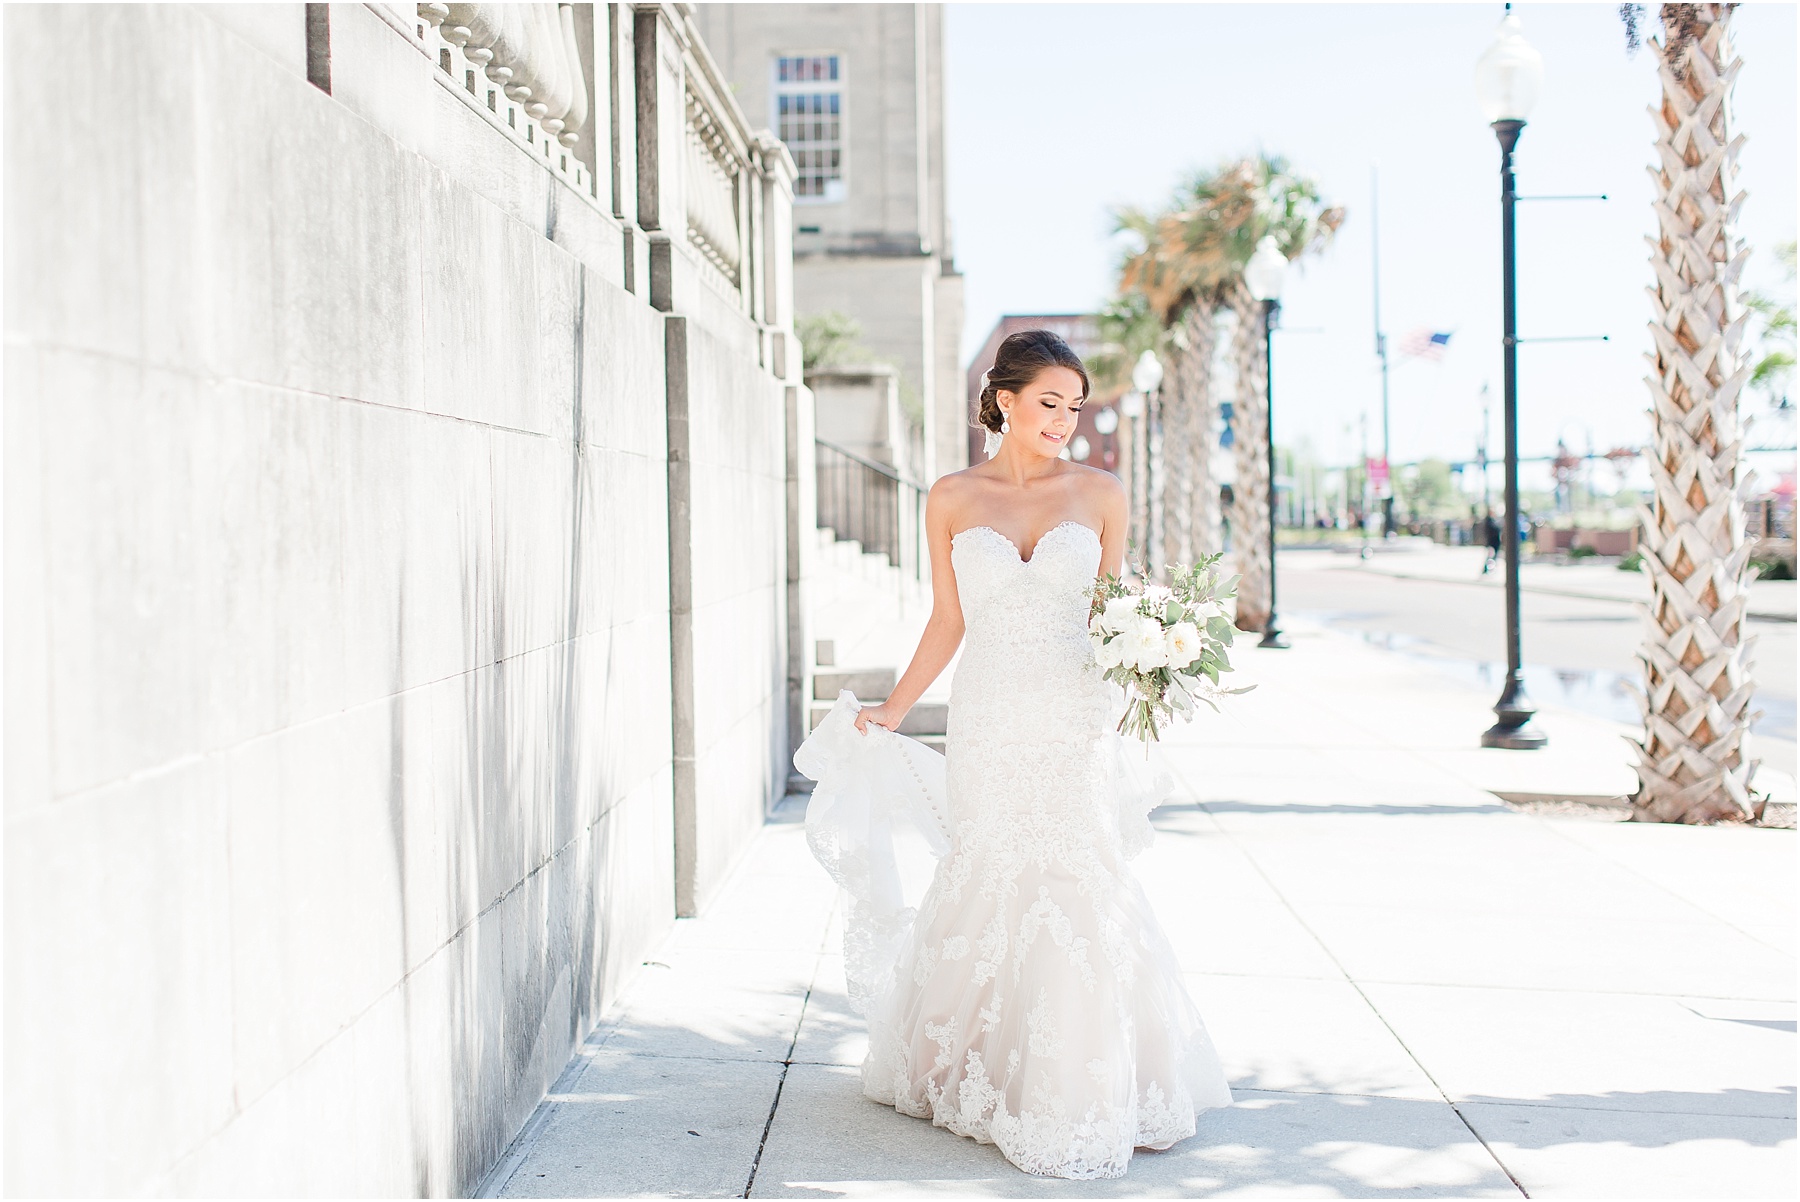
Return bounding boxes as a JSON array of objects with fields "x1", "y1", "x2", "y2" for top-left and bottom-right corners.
[{"x1": 947, "y1": 4, "x2": 1796, "y2": 475}]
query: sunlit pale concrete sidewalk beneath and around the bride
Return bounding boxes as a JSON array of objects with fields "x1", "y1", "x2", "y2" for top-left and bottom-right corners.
[{"x1": 488, "y1": 628, "x2": 1795, "y2": 1198}]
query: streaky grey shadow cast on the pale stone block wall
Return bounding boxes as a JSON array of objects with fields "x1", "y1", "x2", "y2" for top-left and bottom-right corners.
[{"x1": 387, "y1": 326, "x2": 648, "y2": 1197}]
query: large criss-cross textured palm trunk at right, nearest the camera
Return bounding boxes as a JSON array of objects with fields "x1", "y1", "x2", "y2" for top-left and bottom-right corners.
[{"x1": 1633, "y1": 4, "x2": 1762, "y2": 822}]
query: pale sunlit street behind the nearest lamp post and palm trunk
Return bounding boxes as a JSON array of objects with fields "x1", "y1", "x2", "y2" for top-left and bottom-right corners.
[{"x1": 1278, "y1": 549, "x2": 1795, "y2": 774}]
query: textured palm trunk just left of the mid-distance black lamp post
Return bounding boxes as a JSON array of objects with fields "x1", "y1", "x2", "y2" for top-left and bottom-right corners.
[{"x1": 1228, "y1": 279, "x2": 1271, "y2": 630}]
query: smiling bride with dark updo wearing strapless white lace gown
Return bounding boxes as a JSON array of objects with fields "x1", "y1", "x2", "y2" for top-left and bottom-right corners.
[{"x1": 808, "y1": 329, "x2": 1231, "y2": 1179}]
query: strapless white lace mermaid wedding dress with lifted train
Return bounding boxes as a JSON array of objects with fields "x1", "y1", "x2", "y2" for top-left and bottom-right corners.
[{"x1": 794, "y1": 522, "x2": 1231, "y2": 1179}]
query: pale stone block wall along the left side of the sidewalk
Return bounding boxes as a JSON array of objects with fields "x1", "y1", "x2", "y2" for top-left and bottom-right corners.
[{"x1": 4, "y1": 5, "x2": 795, "y2": 1195}]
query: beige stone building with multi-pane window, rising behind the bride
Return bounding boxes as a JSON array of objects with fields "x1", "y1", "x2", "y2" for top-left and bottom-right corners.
[{"x1": 695, "y1": 4, "x2": 968, "y2": 480}]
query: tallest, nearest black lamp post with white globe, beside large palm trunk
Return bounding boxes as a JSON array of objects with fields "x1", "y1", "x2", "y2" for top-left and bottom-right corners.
[{"x1": 1474, "y1": 4, "x2": 1548, "y2": 750}]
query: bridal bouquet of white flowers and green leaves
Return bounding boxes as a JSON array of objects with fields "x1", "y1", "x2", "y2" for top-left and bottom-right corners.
[{"x1": 1087, "y1": 554, "x2": 1255, "y2": 747}]
